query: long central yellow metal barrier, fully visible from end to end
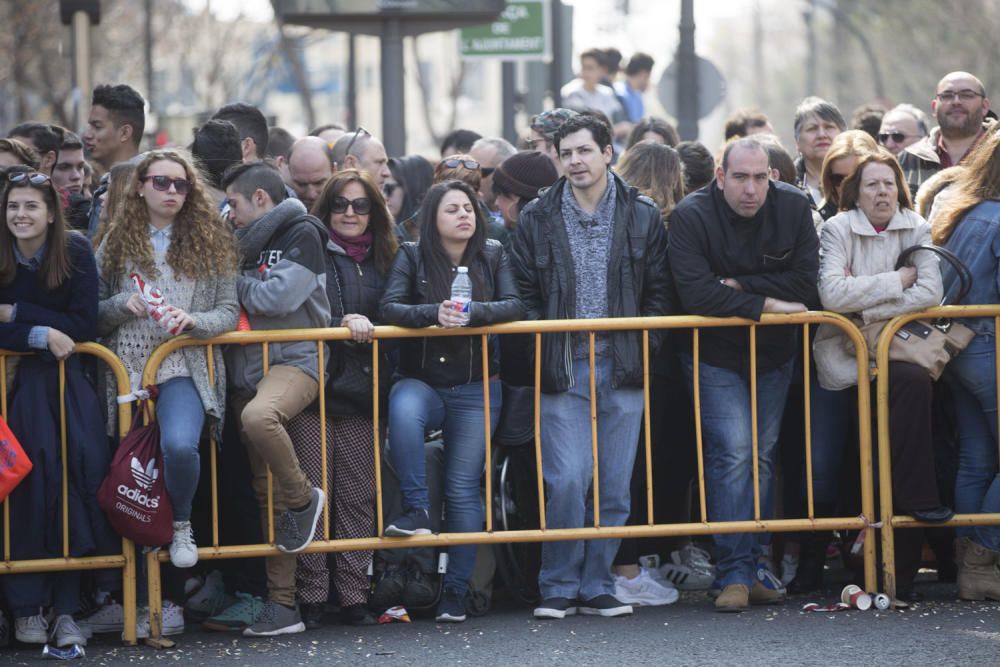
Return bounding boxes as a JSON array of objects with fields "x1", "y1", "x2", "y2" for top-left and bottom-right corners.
[{"x1": 143, "y1": 312, "x2": 876, "y2": 638}]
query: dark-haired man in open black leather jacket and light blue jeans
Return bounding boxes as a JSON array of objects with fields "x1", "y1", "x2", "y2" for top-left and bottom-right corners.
[{"x1": 514, "y1": 116, "x2": 670, "y2": 618}]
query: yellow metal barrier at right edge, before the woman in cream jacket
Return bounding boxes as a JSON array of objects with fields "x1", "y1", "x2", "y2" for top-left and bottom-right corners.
[{"x1": 875, "y1": 305, "x2": 1000, "y2": 597}]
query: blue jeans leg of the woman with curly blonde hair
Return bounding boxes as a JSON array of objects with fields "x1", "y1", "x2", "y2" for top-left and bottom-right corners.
[{"x1": 156, "y1": 377, "x2": 205, "y2": 521}]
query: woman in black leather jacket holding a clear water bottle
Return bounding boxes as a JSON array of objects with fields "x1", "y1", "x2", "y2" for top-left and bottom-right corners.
[{"x1": 381, "y1": 181, "x2": 524, "y2": 622}]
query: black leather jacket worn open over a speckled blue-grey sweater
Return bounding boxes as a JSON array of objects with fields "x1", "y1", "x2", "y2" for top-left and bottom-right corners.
[{"x1": 513, "y1": 172, "x2": 674, "y2": 393}]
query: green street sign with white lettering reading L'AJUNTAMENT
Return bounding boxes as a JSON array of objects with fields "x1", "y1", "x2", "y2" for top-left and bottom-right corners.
[{"x1": 458, "y1": 0, "x2": 552, "y2": 60}]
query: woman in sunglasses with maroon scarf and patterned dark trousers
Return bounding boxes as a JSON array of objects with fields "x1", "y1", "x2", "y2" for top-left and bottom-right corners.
[{"x1": 276, "y1": 169, "x2": 397, "y2": 629}]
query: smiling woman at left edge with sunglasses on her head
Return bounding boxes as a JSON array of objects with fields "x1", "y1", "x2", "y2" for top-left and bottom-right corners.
[{"x1": 0, "y1": 171, "x2": 121, "y2": 646}]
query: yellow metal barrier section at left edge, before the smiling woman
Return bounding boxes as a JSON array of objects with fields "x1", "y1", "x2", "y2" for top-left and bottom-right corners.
[{"x1": 0, "y1": 343, "x2": 136, "y2": 645}]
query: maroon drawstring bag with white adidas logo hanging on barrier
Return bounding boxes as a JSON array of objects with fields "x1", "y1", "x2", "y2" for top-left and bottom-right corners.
[{"x1": 97, "y1": 401, "x2": 174, "y2": 547}]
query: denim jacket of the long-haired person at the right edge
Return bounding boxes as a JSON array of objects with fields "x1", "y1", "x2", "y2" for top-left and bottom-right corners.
[{"x1": 941, "y1": 201, "x2": 1000, "y2": 336}]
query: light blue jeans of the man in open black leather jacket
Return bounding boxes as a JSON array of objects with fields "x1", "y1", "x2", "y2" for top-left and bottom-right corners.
[{"x1": 538, "y1": 357, "x2": 643, "y2": 600}]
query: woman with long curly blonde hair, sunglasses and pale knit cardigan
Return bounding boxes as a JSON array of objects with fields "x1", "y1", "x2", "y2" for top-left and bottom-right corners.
[{"x1": 96, "y1": 150, "x2": 238, "y2": 567}]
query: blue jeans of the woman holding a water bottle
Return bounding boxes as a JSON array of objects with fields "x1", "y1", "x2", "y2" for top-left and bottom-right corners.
[{"x1": 389, "y1": 378, "x2": 501, "y2": 594}]
